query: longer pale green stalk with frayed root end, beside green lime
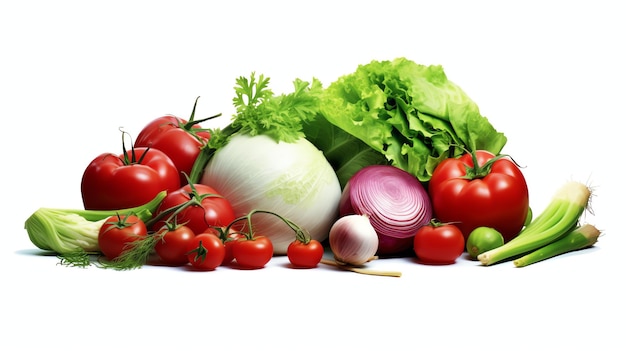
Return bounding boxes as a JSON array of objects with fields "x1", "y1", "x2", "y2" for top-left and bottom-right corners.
[{"x1": 478, "y1": 181, "x2": 591, "y2": 265}]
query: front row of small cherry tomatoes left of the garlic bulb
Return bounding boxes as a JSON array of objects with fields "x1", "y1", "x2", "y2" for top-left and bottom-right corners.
[{"x1": 98, "y1": 210, "x2": 324, "y2": 271}]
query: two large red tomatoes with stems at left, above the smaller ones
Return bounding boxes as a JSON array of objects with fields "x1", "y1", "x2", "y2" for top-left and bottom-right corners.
[{"x1": 81, "y1": 99, "x2": 212, "y2": 210}]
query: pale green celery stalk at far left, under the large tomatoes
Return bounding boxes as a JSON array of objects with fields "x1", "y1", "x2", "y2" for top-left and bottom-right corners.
[{"x1": 24, "y1": 191, "x2": 167, "y2": 254}]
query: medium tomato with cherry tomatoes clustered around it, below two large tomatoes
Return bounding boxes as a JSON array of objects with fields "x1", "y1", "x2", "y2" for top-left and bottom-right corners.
[{"x1": 91, "y1": 161, "x2": 274, "y2": 270}]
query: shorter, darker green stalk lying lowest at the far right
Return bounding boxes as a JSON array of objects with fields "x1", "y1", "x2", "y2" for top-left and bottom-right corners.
[{"x1": 513, "y1": 224, "x2": 600, "y2": 267}]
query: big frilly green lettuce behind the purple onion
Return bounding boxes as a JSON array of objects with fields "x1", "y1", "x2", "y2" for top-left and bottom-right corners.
[{"x1": 304, "y1": 58, "x2": 507, "y2": 182}]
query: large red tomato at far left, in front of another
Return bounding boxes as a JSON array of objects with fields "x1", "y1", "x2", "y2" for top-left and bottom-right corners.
[{"x1": 81, "y1": 148, "x2": 180, "y2": 210}]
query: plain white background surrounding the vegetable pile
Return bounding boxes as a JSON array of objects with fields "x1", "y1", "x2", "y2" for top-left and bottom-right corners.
[{"x1": 0, "y1": 0, "x2": 626, "y2": 350}]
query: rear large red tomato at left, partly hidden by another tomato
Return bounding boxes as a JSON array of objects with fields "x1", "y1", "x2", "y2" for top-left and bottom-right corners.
[{"x1": 135, "y1": 115, "x2": 209, "y2": 185}]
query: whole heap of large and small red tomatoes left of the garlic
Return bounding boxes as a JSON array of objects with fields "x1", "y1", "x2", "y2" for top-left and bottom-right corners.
[{"x1": 81, "y1": 99, "x2": 324, "y2": 270}]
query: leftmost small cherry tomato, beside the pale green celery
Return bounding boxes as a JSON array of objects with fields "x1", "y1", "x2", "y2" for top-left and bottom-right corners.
[{"x1": 98, "y1": 215, "x2": 148, "y2": 260}]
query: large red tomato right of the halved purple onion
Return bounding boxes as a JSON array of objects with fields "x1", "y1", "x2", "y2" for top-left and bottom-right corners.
[{"x1": 429, "y1": 151, "x2": 529, "y2": 241}]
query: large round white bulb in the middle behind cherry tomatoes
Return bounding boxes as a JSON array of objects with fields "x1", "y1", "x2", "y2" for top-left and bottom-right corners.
[{"x1": 200, "y1": 134, "x2": 341, "y2": 255}]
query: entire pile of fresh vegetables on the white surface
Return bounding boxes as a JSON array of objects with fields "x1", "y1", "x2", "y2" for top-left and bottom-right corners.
[{"x1": 25, "y1": 58, "x2": 600, "y2": 276}]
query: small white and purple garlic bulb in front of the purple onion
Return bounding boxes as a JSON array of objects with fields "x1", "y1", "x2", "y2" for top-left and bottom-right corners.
[{"x1": 328, "y1": 214, "x2": 378, "y2": 266}]
